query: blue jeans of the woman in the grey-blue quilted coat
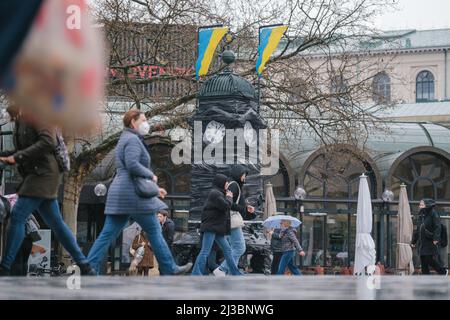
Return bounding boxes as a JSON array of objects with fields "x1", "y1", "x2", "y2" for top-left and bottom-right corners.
[{"x1": 88, "y1": 213, "x2": 178, "y2": 275}]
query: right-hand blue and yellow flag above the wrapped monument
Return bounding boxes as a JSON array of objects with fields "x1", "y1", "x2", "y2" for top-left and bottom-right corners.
[{"x1": 256, "y1": 26, "x2": 288, "y2": 77}]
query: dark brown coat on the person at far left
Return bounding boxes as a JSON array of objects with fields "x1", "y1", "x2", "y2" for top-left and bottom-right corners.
[{"x1": 0, "y1": 120, "x2": 62, "y2": 199}]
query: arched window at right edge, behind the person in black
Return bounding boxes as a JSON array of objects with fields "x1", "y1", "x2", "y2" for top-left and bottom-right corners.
[{"x1": 392, "y1": 152, "x2": 450, "y2": 200}]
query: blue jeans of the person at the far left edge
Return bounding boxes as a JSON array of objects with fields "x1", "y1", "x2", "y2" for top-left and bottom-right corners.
[{"x1": 1, "y1": 196, "x2": 88, "y2": 269}]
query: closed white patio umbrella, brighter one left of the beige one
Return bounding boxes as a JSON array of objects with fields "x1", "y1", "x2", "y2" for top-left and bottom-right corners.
[{"x1": 353, "y1": 174, "x2": 376, "y2": 275}]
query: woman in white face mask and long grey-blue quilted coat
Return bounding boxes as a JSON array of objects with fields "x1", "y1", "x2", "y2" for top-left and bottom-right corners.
[{"x1": 88, "y1": 109, "x2": 192, "y2": 275}]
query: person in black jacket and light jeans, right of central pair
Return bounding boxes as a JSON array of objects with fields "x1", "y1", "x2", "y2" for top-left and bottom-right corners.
[{"x1": 214, "y1": 164, "x2": 255, "y2": 276}]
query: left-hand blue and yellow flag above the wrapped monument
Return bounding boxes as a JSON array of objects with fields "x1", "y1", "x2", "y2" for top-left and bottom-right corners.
[{"x1": 195, "y1": 27, "x2": 229, "y2": 79}]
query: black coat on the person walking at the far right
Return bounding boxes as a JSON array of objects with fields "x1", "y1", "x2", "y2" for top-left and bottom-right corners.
[{"x1": 411, "y1": 199, "x2": 441, "y2": 256}]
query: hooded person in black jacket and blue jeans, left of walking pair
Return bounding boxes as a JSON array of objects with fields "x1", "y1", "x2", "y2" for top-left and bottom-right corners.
[{"x1": 192, "y1": 174, "x2": 241, "y2": 276}]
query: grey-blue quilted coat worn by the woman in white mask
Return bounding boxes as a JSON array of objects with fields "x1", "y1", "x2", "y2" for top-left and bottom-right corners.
[{"x1": 105, "y1": 128, "x2": 167, "y2": 215}]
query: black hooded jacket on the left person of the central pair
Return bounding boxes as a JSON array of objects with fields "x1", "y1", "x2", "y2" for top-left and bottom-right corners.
[{"x1": 200, "y1": 174, "x2": 232, "y2": 235}]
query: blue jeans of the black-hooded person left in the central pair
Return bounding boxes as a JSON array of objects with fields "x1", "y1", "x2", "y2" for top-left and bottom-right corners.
[{"x1": 192, "y1": 232, "x2": 242, "y2": 276}]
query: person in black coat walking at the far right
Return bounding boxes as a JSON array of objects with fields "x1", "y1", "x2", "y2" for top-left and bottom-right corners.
[{"x1": 411, "y1": 199, "x2": 448, "y2": 275}]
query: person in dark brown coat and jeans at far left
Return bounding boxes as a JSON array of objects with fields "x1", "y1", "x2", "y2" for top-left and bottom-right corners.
[{"x1": 0, "y1": 106, "x2": 93, "y2": 275}]
